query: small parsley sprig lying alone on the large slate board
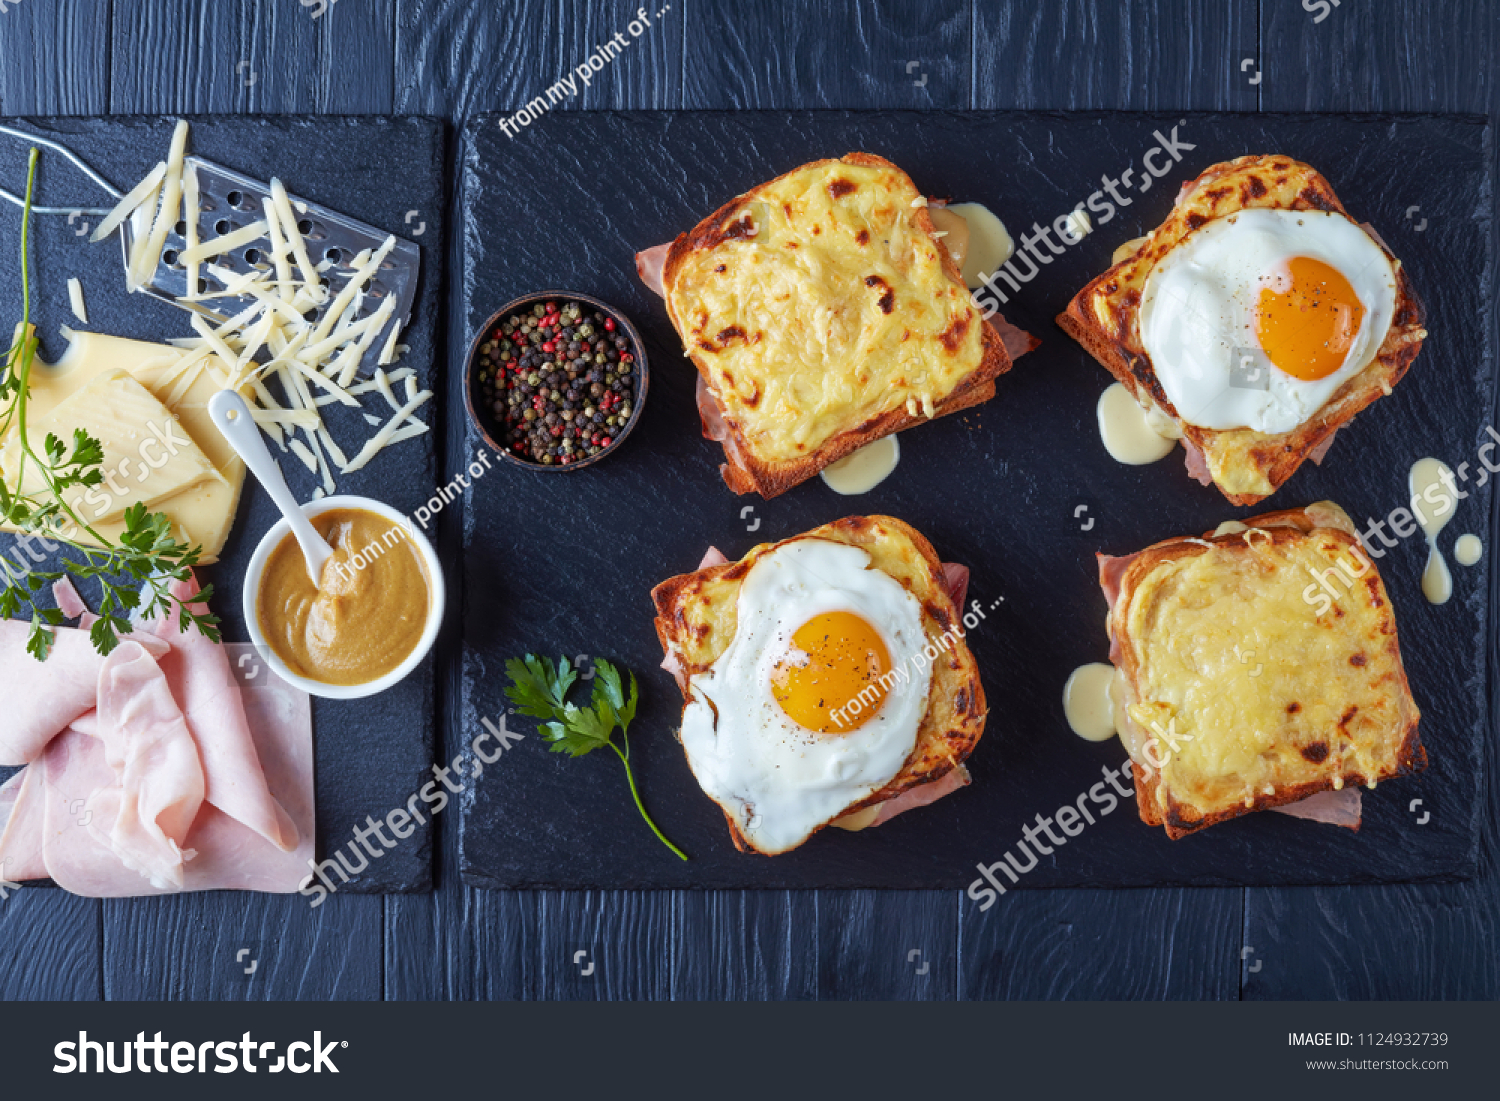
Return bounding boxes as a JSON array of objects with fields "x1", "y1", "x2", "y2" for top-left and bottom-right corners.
[{"x1": 506, "y1": 654, "x2": 687, "y2": 860}]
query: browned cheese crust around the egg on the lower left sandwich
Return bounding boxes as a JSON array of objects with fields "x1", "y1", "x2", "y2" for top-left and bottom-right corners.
[{"x1": 651, "y1": 516, "x2": 986, "y2": 852}]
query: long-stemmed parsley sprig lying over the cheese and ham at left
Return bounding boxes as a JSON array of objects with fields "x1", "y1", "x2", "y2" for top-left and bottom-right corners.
[{"x1": 0, "y1": 149, "x2": 219, "y2": 662}]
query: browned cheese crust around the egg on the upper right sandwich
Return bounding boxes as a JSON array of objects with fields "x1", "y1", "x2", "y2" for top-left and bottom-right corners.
[{"x1": 1058, "y1": 156, "x2": 1427, "y2": 504}]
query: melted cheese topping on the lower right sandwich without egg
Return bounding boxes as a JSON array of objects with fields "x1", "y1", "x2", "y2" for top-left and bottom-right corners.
[{"x1": 1127, "y1": 530, "x2": 1416, "y2": 815}]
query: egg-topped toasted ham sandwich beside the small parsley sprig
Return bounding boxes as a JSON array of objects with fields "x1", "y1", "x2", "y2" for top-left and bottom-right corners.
[{"x1": 651, "y1": 516, "x2": 986, "y2": 855}]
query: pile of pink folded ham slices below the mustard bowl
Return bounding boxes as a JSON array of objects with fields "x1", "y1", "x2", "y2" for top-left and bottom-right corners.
[{"x1": 0, "y1": 582, "x2": 315, "y2": 899}]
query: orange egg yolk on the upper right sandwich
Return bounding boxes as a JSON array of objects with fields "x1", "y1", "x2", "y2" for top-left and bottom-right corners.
[{"x1": 1256, "y1": 257, "x2": 1365, "y2": 383}]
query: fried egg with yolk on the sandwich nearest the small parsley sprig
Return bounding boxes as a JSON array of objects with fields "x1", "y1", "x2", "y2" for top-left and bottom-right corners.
[{"x1": 683, "y1": 539, "x2": 930, "y2": 854}]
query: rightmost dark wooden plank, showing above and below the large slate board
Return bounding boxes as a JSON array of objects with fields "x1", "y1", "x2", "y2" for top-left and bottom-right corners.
[{"x1": 1244, "y1": 0, "x2": 1500, "y2": 1001}]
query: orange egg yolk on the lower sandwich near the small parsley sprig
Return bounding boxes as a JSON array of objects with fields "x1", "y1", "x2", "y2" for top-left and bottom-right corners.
[{"x1": 771, "y1": 612, "x2": 891, "y2": 734}]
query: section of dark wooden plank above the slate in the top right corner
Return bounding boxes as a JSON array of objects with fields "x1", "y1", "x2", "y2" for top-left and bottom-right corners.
[{"x1": 1260, "y1": 0, "x2": 1500, "y2": 114}]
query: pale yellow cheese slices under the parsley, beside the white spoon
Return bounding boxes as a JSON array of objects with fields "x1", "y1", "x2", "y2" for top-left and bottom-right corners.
[{"x1": 3, "y1": 330, "x2": 251, "y2": 563}]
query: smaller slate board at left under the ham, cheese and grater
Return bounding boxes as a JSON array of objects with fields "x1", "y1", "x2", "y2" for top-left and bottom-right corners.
[{"x1": 0, "y1": 117, "x2": 447, "y2": 893}]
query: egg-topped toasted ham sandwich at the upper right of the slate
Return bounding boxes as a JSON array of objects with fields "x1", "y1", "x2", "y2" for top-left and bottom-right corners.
[{"x1": 1058, "y1": 156, "x2": 1427, "y2": 504}]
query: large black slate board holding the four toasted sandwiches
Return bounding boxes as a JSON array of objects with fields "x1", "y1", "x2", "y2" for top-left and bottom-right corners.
[{"x1": 450, "y1": 111, "x2": 1496, "y2": 888}]
